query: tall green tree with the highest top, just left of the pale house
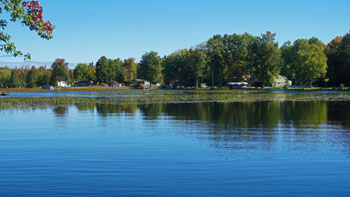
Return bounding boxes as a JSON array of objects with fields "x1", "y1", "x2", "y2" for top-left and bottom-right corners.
[{"x1": 249, "y1": 31, "x2": 282, "y2": 86}]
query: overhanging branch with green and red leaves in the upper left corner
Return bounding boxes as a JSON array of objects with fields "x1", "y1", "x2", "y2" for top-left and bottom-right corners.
[{"x1": 0, "y1": 0, "x2": 55, "y2": 59}]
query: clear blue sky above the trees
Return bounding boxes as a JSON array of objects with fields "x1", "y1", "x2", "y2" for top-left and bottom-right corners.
[{"x1": 0, "y1": 0, "x2": 350, "y2": 63}]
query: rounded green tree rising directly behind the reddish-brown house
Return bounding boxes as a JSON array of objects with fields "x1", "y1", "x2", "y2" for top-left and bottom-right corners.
[{"x1": 138, "y1": 51, "x2": 163, "y2": 83}]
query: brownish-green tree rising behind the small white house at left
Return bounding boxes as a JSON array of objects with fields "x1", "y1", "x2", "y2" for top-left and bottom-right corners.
[{"x1": 50, "y1": 58, "x2": 70, "y2": 86}]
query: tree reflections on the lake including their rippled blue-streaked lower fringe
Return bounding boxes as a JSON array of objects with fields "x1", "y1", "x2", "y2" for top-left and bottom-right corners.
[{"x1": 0, "y1": 101, "x2": 350, "y2": 152}]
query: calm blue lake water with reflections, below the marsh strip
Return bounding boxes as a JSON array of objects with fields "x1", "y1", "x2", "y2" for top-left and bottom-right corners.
[{"x1": 0, "y1": 101, "x2": 350, "y2": 196}]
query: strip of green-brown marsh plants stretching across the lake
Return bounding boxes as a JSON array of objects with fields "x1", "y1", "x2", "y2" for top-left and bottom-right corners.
[{"x1": 0, "y1": 90, "x2": 350, "y2": 106}]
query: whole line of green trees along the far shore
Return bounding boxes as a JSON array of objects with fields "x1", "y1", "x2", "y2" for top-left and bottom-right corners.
[{"x1": 0, "y1": 32, "x2": 350, "y2": 88}]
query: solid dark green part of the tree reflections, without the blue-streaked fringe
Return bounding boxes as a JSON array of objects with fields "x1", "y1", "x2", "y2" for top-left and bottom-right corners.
[{"x1": 68, "y1": 101, "x2": 350, "y2": 132}]
